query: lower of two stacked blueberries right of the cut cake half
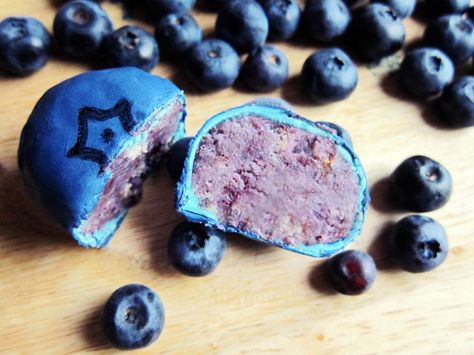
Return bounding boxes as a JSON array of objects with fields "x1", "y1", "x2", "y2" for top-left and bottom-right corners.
[{"x1": 389, "y1": 215, "x2": 448, "y2": 272}]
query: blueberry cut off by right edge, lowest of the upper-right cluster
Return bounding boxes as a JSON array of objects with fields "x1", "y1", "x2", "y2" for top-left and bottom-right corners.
[{"x1": 439, "y1": 76, "x2": 474, "y2": 127}]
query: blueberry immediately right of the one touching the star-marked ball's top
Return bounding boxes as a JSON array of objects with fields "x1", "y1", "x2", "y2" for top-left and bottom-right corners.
[{"x1": 155, "y1": 14, "x2": 202, "y2": 57}]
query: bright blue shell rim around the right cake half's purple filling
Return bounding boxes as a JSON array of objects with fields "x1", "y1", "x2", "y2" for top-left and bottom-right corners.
[{"x1": 176, "y1": 104, "x2": 370, "y2": 257}]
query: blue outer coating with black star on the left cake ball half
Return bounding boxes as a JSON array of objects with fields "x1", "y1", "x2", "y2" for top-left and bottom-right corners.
[{"x1": 18, "y1": 67, "x2": 185, "y2": 247}]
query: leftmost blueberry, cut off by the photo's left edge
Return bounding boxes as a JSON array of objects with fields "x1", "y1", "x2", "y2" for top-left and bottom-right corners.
[{"x1": 0, "y1": 17, "x2": 51, "y2": 75}]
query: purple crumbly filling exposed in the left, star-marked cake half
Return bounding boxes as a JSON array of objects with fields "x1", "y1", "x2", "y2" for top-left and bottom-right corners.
[{"x1": 81, "y1": 101, "x2": 183, "y2": 235}]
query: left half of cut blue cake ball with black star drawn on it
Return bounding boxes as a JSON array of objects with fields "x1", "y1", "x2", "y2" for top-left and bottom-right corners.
[{"x1": 18, "y1": 67, "x2": 185, "y2": 247}]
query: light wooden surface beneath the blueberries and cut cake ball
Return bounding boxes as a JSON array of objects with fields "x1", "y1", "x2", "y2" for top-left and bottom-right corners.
[{"x1": 0, "y1": 0, "x2": 474, "y2": 354}]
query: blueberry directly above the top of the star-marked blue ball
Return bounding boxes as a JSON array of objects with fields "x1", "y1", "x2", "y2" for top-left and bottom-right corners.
[{"x1": 104, "y1": 26, "x2": 159, "y2": 71}]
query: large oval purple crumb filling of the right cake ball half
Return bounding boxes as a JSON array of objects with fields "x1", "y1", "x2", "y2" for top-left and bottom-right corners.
[{"x1": 192, "y1": 117, "x2": 359, "y2": 245}]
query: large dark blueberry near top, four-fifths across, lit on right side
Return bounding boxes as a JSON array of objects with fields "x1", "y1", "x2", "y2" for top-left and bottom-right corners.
[{"x1": 348, "y1": 3, "x2": 405, "y2": 61}]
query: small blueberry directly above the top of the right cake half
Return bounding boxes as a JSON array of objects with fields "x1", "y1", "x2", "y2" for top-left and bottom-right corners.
[{"x1": 241, "y1": 45, "x2": 288, "y2": 92}]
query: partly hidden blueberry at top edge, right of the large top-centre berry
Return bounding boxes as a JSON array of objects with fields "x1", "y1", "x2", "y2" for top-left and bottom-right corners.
[{"x1": 262, "y1": 0, "x2": 301, "y2": 41}]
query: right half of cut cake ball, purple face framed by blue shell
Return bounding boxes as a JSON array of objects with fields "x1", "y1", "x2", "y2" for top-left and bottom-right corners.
[{"x1": 176, "y1": 103, "x2": 369, "y2": 257}]
